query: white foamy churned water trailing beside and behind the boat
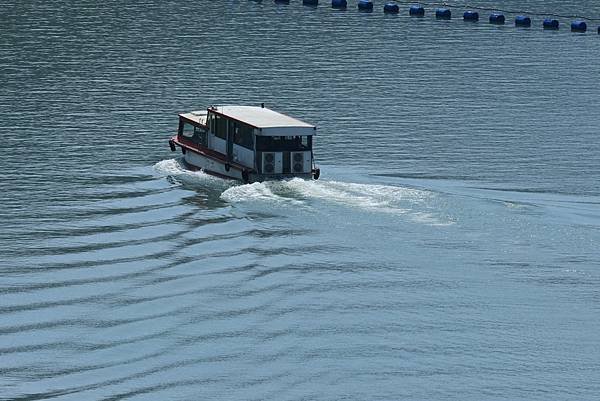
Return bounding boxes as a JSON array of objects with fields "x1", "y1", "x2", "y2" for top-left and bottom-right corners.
[{"x1": 154, "y1": 159, "x2": 453, "y2": 225}]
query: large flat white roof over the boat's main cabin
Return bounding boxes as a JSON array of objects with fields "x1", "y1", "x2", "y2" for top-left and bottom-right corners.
[{"x1": 209, "y1": 106, "x2": 316, "y2": 136}]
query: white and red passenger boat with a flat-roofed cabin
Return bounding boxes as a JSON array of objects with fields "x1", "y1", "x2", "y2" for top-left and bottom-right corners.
[{"x1": 169, "y1": 103, "x2": 321, "y2": 183}]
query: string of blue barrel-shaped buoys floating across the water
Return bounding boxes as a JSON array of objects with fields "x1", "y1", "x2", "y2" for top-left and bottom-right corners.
[{"x1": 272, "y1": 0, "x2": 600, "y2": 35}]
